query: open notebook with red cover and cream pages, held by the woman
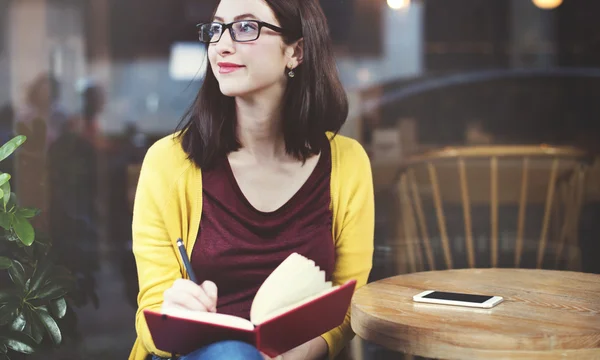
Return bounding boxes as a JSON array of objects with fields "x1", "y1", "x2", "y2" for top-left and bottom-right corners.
[{"x1": 144, "y1": 253, "x2": 356, "y2": 356}]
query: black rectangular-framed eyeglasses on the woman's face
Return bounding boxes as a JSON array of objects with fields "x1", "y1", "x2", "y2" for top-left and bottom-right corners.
[{"x1": 196, "y1": 20, "x2": 286, "y2": 43}]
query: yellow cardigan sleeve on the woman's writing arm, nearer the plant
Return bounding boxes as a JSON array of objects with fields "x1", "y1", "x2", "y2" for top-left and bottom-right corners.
[{"x1": 132, "y1": 142, "x2": 181, "y2": 358}]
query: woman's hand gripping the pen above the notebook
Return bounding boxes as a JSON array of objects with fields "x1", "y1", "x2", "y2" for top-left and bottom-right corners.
[{"x1": 162, "y1": 279, "x2": 217, "y2": 312}]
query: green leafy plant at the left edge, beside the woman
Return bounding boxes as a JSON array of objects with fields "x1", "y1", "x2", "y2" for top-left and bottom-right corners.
[{"x1": 0, "y1": 135, "x2": 76, "y2": 360}]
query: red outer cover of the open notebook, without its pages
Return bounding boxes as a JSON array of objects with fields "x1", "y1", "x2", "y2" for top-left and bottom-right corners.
[{"x1": 144, "y1": 280, "x2": 356, "y2": 357}]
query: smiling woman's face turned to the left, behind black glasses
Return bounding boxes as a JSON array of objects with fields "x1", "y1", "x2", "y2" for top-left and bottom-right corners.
[{"x1": 208, "y1": 0, "x2": 298, "y2": 97}]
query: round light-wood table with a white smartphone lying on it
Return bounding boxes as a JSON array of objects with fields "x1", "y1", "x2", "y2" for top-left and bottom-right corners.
[{"x1": 352, "y1": 269, "x2": 600, "y2": 360}]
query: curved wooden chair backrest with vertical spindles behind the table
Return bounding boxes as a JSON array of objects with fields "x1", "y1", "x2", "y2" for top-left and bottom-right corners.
[{"x1": 397, "y1": 145, "x2": 587, "y2": 272}]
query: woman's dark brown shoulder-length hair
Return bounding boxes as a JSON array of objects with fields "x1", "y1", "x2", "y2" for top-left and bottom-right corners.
[{"x1": 178, "y1": 0, "x2": 348, "y2": 169}]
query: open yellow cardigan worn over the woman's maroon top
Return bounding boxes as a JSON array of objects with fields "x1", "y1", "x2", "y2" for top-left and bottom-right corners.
[{"x1": 129, "y1": 134, "x2": 374, "y2": 360}]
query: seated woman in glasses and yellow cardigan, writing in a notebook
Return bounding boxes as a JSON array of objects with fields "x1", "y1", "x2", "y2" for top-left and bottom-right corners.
[{"x1": 130, "y1": 0, "x2": 374, "y2": 360}]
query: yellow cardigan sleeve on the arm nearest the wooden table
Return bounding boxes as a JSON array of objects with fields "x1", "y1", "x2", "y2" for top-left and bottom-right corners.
[{"x1": 323, "y1": 140, "x2": 375, "y2": 359}]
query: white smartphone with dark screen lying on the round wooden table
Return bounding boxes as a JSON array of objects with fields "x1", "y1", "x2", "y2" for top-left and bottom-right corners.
[{"x1": 413, "y1": 290, "x2": 504, "y2": 309}]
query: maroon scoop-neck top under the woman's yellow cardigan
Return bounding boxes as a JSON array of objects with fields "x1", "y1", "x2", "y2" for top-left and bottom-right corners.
[{"x1": 191, "y1": 142, "x2": 335, "y2": 319}]
